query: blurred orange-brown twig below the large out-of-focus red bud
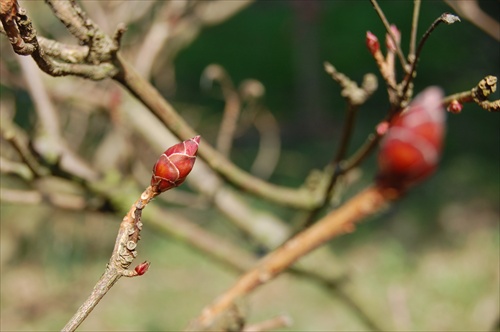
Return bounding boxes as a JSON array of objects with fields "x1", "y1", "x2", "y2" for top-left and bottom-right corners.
[{"x1": 188, "y1": 187, "x2": 392, "y2": 331}]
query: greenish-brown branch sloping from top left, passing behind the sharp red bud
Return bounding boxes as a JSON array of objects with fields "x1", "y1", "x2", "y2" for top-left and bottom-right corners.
[{"x1": 1, "y1": 0, "x2": 321, "y2": 209}]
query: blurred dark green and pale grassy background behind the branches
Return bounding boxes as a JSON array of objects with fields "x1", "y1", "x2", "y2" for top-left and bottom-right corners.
[{"x1": 0, "y1": 0, "x2": 500, "y2": 331}]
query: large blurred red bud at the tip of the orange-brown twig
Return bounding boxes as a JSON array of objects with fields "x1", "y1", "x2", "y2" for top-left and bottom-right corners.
[{"x1": 377, "y1": 87, "x2": 446, "y2": 190}]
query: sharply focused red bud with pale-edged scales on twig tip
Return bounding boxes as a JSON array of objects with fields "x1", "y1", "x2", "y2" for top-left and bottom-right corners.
[{"x1": 151, "y1": 136, "x2": 200, "y2": 192}]
